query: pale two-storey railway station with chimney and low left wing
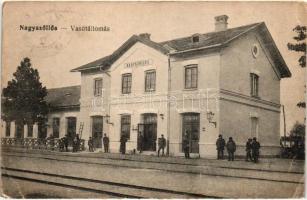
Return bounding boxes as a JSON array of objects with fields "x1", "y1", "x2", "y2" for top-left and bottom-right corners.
[{"x1": 3, "y1": 15, "x2": 291, "y2": 157}]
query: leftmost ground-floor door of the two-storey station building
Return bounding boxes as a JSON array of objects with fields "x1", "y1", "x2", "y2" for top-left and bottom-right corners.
[{"x1": 92, "y1": 116, "x2": 103, "y2": 148}]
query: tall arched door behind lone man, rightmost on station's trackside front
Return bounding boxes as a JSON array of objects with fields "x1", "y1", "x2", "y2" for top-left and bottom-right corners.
[{"x1": 182, "y1": 113, "x2": 199, "y2": 153}]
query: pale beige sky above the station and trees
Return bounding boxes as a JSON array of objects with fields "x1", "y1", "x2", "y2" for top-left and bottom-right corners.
[{"x1": 1, "y1": 2, "x2": 307, "y2": 132}]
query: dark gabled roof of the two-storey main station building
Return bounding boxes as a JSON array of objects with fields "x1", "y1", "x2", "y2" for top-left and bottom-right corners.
[{"x1": 71, "y1": 22, "x2": 291, "y2": 78}]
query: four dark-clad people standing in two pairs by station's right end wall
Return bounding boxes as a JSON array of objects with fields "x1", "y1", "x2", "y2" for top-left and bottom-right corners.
[{"x1": 216, "y1": 134, "x2": 260, "y2": 163}]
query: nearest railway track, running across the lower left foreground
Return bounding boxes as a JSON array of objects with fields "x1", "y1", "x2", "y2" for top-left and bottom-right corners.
[{"x1": 1, "y1": 167, "x2": 221, "y2": 199}]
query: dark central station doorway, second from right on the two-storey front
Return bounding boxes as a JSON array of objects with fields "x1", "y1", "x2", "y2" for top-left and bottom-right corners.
[{"x1": 143, "y1": 113, "x2": 157, "y2": 151}]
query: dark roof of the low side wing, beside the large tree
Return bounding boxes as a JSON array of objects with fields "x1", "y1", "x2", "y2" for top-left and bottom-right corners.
[{"x1": 45, "y1": 85, "x2": 81, "y2": 109}]
